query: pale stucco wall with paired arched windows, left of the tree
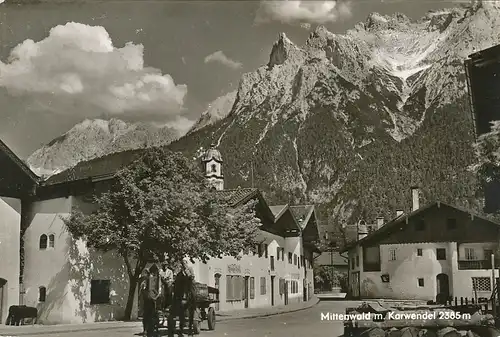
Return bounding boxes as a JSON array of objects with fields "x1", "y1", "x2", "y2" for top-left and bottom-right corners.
[{"x1": 24, "y1": 197, "x2": 137, "y2": 324}]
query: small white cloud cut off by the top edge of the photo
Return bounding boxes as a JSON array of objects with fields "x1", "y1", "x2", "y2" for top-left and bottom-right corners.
[{"x1": 255, "y1": 0, "x2": 351, "y2": 24}]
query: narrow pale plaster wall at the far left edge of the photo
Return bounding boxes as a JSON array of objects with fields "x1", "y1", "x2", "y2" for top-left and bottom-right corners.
[{"x1": 0, "y1": 197, "x2": 21, "y2": 324}]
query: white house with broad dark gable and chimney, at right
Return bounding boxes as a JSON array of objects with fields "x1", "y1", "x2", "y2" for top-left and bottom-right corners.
[{"x1": 342, "y1": 189, "x2": 500, "y2": 300}]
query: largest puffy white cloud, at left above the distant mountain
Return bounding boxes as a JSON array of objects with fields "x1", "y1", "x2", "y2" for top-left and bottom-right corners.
[{"x1": 0, "y1": 22, "x2": 187, "y2": 117}]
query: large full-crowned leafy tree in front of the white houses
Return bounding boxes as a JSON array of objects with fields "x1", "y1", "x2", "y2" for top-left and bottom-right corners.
[{"x1": 64, "y1": 148, "x2": 259, "y2": 320}]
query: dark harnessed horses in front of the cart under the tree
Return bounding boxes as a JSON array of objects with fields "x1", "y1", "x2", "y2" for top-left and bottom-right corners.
[{"x1": 141, "y1": 263, "x2": 196, "y2": 337}]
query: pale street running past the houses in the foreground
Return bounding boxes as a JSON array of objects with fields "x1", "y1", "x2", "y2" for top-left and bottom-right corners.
[{"x1": 9, "y1": 301, "x2": 352, "y2": 337}]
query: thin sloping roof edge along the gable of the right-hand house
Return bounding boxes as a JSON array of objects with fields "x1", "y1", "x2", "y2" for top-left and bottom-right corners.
[{"x1": 340, "y1": 201, "x2": 500, "y2": 253}]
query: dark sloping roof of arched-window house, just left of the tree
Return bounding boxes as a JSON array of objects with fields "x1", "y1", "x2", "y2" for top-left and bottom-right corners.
[{"x1": 44, "y1": 149, "x2": 144, "y2": 185}]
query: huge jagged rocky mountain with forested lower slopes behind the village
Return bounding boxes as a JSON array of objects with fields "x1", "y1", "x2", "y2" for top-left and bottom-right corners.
[{"x1": 28, "y1": 2, "x2": 500, "y2": 242}]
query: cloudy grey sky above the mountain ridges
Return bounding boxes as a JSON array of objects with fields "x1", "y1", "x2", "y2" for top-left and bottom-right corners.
[{"x1": 0, "y1": 0, "x2": 466, "y2": 158}]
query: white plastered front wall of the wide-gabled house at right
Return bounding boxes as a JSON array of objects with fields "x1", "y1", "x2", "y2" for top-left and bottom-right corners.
[{"x1": 349, "y1": 242, "x2": 498, "y2": 301}]
